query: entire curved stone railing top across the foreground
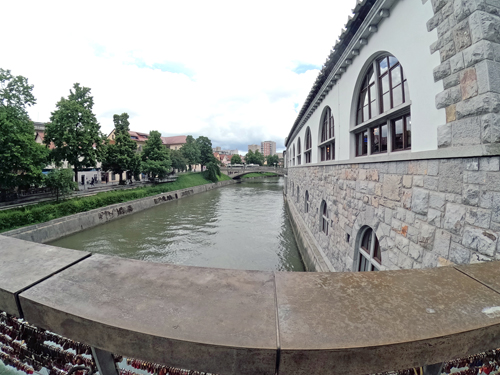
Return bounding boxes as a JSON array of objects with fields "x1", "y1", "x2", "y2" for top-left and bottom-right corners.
[{"x1": 0, "y1": 236, "x2": 500, "y2": 375}]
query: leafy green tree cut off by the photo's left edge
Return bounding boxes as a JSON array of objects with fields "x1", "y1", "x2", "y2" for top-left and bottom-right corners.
[{"x1": 0, "y1": 68, "x2": 48, "y2": 199}]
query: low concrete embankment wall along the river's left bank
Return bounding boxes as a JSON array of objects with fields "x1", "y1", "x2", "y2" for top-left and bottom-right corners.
[{"x1": 2, "y1": 180, "x2": 236, "y2": 243}]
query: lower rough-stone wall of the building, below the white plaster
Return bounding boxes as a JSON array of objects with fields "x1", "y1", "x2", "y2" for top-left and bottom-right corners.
[{"x1": 287, "y1": 156, "x2": 500, "y2": 271}]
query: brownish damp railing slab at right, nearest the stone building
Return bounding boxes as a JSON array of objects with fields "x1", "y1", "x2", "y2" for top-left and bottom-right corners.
[{"x1": 276, "y1": 267, "x2": 500, "y2": 375}]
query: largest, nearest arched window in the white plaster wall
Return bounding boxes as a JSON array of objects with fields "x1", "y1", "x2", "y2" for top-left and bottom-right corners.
[{"x1": 355, "y1": 55, "x2": 411, "y2": 156}]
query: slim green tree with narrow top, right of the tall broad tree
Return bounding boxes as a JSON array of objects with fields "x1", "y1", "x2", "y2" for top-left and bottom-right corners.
[{"x1": 102, "y1": 113, "x2": 139, "y2": 185}]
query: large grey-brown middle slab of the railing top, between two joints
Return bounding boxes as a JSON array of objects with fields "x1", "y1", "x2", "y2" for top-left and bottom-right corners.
[{"x1": 20, "y1": 255, "x2": 277, "y2": 375}]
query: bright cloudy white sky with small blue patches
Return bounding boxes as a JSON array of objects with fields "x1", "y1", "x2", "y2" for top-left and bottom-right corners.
[{"x1": 0, "y1": 0, "x2": 355, "y2": 152}]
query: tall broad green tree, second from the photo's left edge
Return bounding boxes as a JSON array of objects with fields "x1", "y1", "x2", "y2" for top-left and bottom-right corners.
[{"x1": 44, "y1": 83, "x2": 104, "y2": 186}]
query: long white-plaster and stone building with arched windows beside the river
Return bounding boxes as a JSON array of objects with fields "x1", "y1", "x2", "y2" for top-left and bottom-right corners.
[{"x1": 285, "y1": 0, "x2": 500, "y2": 271}]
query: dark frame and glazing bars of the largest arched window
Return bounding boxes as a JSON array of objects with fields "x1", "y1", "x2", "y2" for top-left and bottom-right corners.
[{"x1": 351, "y1": 54, "x2": 411, "y2": 157}]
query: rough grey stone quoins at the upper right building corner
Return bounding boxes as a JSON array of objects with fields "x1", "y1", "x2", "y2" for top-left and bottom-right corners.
[{"x1": 427, "y1": 0, "x2": 500, "y2": 150}]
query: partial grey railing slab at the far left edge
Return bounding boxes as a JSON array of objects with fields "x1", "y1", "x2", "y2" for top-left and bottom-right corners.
[{"x1": 0, "y1": 236, "x2": 90, "y2": 317}]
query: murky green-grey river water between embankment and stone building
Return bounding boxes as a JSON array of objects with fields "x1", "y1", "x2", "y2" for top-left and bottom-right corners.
[{"x1": 50, "y1": 177, "x2": 304, "y2": 271}]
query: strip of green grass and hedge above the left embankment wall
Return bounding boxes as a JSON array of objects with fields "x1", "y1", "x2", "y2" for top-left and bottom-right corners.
[{"x1": 0, "y1": 173, "x2": 231, "y2": 233}]
